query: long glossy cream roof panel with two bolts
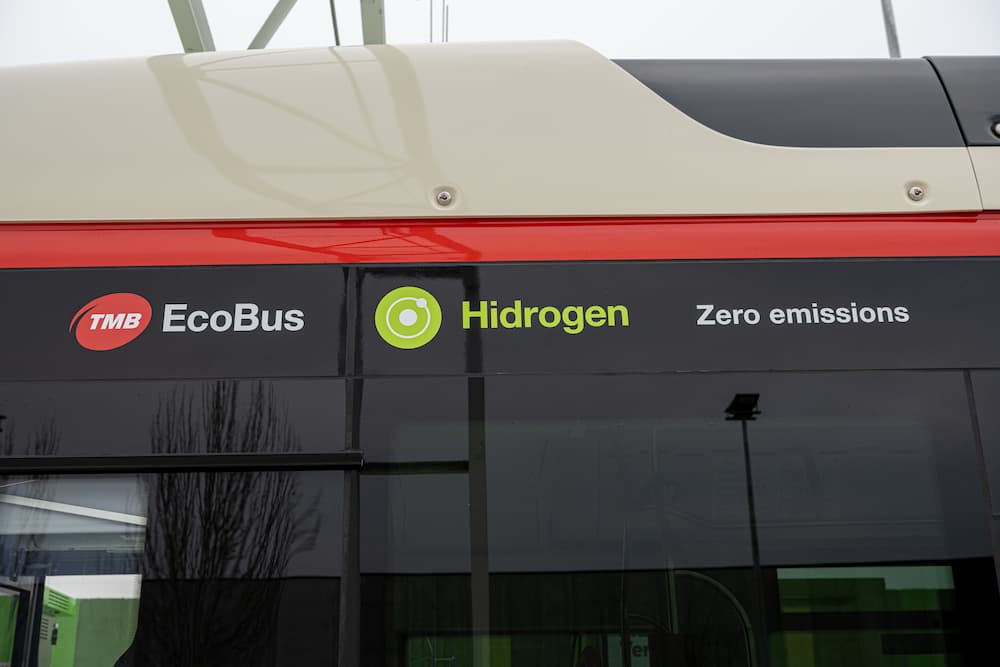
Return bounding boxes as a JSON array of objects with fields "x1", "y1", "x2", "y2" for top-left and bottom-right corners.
[{"x1": 0, "y1": 42, "x2": 982, "y2": 221}]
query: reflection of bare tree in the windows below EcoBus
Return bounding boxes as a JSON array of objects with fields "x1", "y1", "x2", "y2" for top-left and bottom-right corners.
[{"x1": 127, "y1": 381, "x2": 319, "y2": 667}]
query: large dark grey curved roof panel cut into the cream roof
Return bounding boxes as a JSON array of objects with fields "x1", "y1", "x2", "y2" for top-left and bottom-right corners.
[{"x1": 616, "y1": 60, "x2": 964, "y2": 148}]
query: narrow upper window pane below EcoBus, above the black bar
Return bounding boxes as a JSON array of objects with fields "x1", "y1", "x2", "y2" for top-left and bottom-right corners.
[{"x1": 0, "y1": 380, "x2": 345, "y2": 456}]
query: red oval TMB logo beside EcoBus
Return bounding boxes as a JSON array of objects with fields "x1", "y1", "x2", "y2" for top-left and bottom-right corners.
[{"x1": 69, "y1": 292, "x2": 153, "y2": 351}]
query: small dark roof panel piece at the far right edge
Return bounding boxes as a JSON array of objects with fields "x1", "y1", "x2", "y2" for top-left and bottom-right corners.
[{"x1": 928, "y1": 56, "x2": 1000, "y2": 146}]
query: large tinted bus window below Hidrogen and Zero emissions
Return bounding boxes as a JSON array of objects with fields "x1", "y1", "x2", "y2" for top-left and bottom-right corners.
[{"x1": 362, "y1": 371, "x2": 1000, "y2": 667}]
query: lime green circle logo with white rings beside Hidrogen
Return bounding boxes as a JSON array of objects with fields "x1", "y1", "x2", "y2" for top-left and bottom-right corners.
[{"x1": 375, "y1": 287, "x2": 441, "y2": 350}]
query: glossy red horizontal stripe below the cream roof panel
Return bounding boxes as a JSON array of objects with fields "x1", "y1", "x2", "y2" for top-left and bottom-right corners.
[{"x1": 0, "y1": 212, "x2": 1000, "y2": 268}]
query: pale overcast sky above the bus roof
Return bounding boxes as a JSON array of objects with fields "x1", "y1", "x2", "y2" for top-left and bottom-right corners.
[{"x1": 0, "y1": 0, "x2": 1000, "y2": 65}]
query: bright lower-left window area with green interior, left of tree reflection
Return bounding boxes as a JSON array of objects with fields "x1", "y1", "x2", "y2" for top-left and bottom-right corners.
[{"x1": 0, "y1": 476, "x2": 147, "y2": 667}]
